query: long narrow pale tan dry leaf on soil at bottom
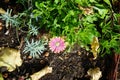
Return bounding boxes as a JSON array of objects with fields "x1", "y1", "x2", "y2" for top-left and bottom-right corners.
[{"x1": 31, "y1": 66, "x2": 52, "y2": 80}]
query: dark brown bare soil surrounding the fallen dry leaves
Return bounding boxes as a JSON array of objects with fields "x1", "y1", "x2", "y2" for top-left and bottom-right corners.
[{"x1": 0, "y1": 29, "x2": 120, "y2": 80}]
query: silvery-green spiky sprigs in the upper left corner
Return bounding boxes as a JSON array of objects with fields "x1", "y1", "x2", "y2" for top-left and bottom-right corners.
[{"x1": 0, "y1": 9, "x2": 39, "y2": 41}]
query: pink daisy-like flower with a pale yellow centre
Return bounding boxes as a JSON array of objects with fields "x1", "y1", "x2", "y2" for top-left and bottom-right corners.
[{"x1": 49, "y1": 37, "x2": 66, "y2": 53}]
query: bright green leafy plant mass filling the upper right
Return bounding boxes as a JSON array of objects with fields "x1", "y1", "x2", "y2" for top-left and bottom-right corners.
[{"x1": 33, "y1": 0, "x2": 120, "y2": 53}]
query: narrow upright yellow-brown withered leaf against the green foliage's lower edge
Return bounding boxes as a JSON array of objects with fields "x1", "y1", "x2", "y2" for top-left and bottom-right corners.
[{"x1": 91, "y1": 37, "x2": 99, "y2": 59}]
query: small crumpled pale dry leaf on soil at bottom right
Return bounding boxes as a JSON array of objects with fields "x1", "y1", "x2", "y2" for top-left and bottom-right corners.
[{"x1": 87, "y1": 67, "x2": 102, "y2": 80}]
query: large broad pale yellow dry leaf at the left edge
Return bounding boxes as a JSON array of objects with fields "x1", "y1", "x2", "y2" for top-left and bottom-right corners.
[{"x1": 0, "y1": 47, "x2": 22, "y2": 72}]
